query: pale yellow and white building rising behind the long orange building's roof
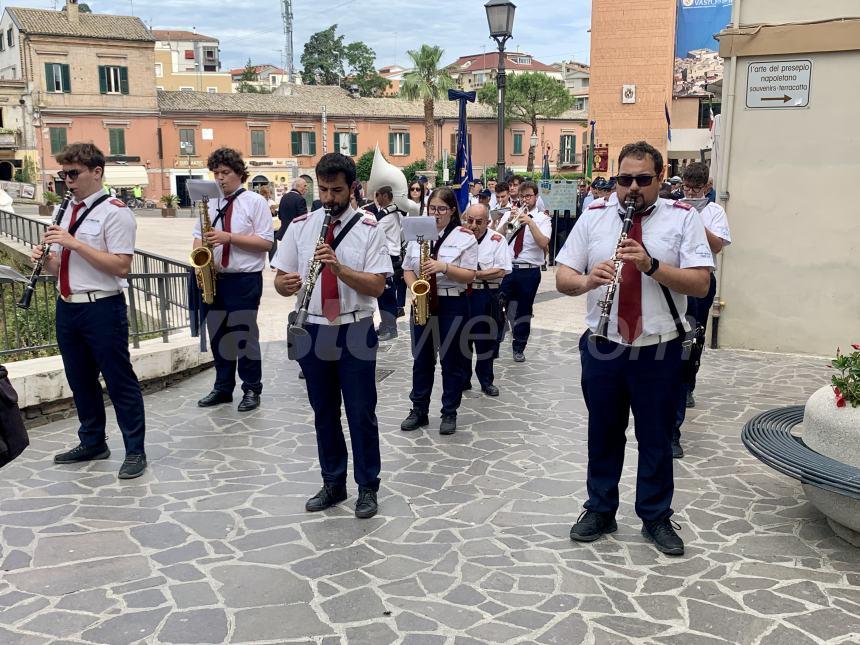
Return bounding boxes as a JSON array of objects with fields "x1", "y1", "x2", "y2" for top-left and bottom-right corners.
[{"x1": 152, "y1": 29, "x2": 233, "y2": 94}]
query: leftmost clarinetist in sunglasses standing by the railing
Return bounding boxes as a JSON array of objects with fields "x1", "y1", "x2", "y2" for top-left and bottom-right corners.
[{"x1": 31, "y1": 143, "x2": 146, "y2": 479}]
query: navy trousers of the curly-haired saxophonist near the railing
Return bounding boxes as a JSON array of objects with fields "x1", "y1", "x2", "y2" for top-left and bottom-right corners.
[{"x1": 203, "y1": 271, "x2": 263, "y2": 394}]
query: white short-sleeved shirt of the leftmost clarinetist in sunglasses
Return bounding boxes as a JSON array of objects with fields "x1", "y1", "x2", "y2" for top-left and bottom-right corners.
[{"x1": 51, "y1": 189, "x2": 137, "y2": 293}]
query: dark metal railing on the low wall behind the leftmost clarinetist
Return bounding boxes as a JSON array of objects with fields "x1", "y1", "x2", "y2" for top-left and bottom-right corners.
[{"x1": 0, "y1": 211, "x2": 193, "y2": 359}]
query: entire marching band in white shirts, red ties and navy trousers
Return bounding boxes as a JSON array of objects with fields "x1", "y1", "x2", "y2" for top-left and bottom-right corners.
[{"x1": 33, "y1": 142, "x2": 731, "y2": 555}]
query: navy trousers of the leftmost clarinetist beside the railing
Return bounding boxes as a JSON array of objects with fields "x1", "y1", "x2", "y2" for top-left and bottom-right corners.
[{"x1": 57, "y1": 294, "x2": 146, "y2": 455}]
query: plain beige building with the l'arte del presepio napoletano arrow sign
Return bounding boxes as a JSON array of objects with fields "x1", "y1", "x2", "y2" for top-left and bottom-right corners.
[{"x1": 717, "y1": 0, "x2": 860, "y2": 354}]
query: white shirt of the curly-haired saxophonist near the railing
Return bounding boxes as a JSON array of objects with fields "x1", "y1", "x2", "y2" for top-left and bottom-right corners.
[{"x1": 194, "y1": 190, "x2": 275, "y2": 273}]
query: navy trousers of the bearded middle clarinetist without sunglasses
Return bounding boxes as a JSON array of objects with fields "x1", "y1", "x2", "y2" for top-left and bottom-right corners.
[{"x1": 298, "y1": 316, "x2": 381, "y2": 490}]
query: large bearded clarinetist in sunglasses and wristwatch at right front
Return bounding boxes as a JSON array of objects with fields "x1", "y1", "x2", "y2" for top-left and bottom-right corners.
[{"x1": 556, "y1": 141, "x2": 713, "y2": 555}]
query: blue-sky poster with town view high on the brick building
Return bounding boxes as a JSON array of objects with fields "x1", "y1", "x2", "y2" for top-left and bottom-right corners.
[{"x1": 674, "y1": 0, "x2": 732, "y2": 96}]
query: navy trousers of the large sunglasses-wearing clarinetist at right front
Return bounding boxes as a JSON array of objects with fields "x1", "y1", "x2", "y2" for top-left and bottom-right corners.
[{"x1": 579, "y1": 332, "x2": 683, "y2": 520}]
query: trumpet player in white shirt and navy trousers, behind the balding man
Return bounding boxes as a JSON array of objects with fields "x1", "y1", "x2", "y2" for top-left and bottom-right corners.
[{"x1": 498, "y1": 181, "x2": 552, "y2": 363}]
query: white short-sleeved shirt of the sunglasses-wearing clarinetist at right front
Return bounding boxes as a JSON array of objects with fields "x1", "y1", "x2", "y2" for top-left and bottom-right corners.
[{"x1": 556, "y1": 199, "x2": 713, "y2": 343}]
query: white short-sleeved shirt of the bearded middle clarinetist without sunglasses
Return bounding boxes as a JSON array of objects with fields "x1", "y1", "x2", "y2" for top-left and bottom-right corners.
[{"x1": 272, "y1": 207, "x2": 394, "y2": 325}]
